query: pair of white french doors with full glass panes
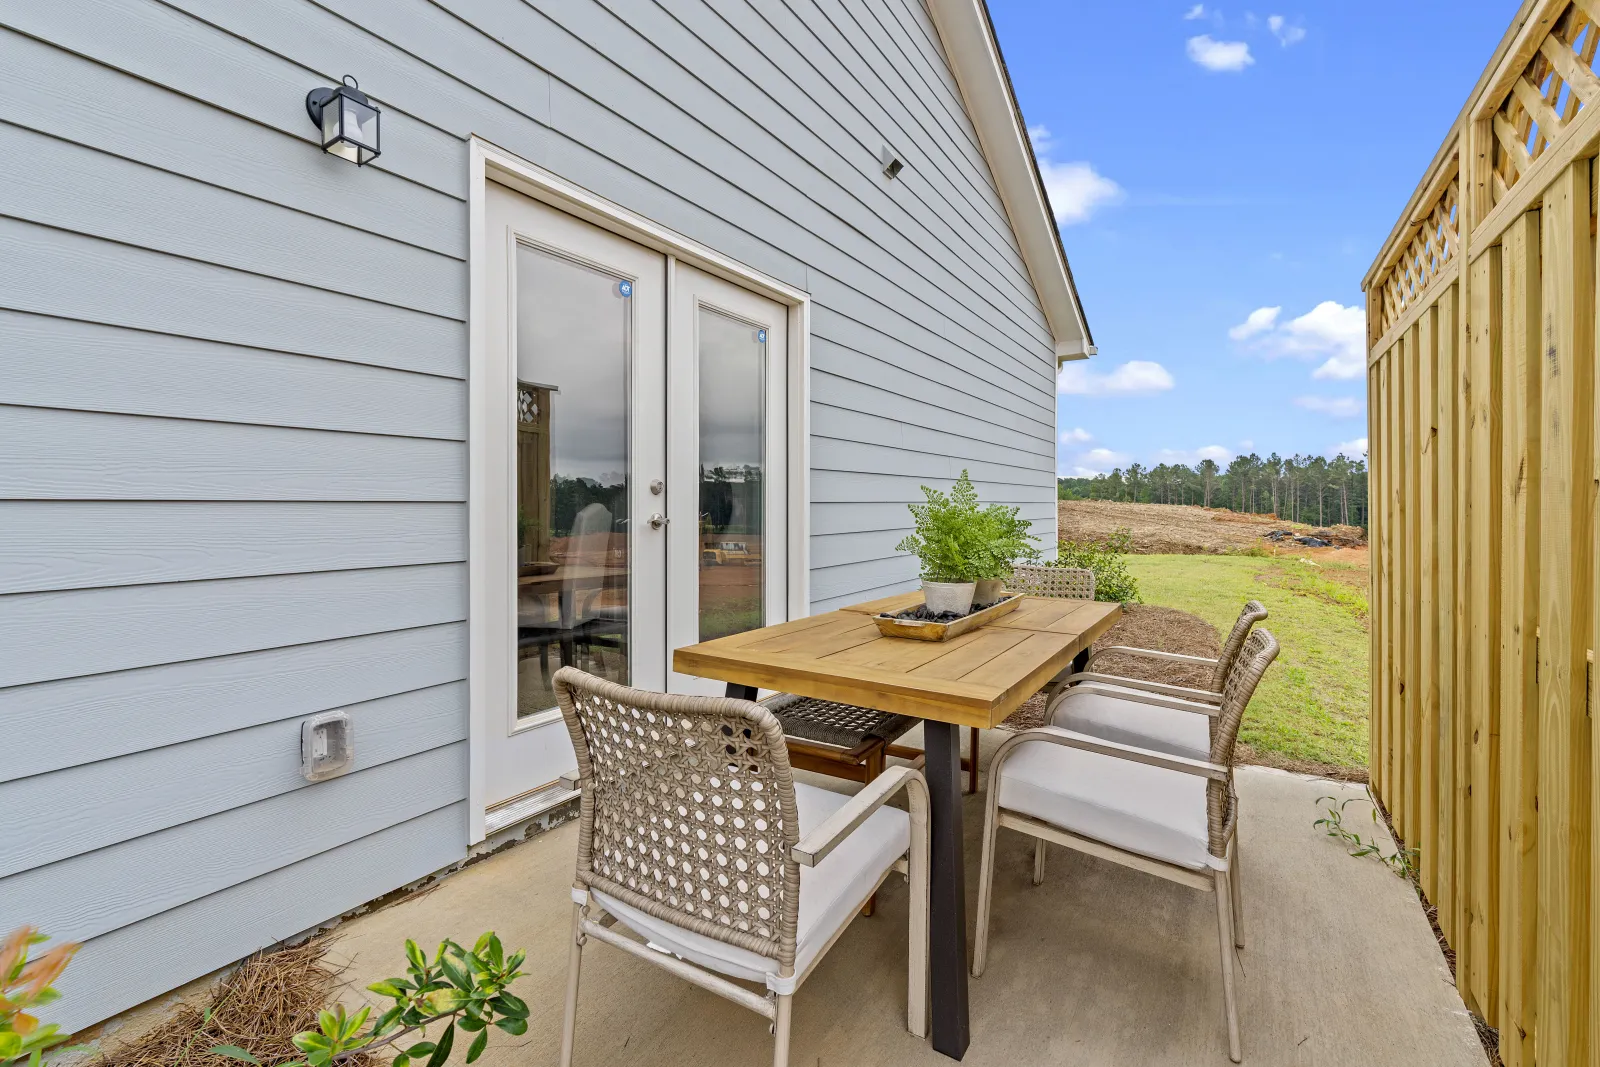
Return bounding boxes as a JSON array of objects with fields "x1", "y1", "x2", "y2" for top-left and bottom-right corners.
[{"x1": 472, "y1": 182, "x2": 789, "y2": 809}]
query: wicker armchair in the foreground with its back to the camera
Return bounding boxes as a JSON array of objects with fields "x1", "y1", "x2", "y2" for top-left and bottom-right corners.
[{"x1": 555, "y1": 667, "x2": 928, "y2": 1067}]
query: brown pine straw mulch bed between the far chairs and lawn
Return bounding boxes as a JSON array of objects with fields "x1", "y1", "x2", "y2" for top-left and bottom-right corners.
[{"x1": 1000, "y1": 605, "x2": 1366, "y2": 784}]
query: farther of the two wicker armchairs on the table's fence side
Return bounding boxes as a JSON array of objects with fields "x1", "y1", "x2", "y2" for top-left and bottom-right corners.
[{"x1": 1048, "y1": 600, "x2": 1267, "y2": 760}]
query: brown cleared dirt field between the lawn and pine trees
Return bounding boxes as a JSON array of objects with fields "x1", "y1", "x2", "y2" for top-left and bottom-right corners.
[{"x1": 1056, "y1": 501, "x2": 1366, "y2": 566}]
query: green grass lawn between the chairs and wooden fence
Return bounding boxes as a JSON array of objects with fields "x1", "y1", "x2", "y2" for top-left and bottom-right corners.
[{"x1": 1128, "y1": 555, "x2": 1368, "y2": 766}]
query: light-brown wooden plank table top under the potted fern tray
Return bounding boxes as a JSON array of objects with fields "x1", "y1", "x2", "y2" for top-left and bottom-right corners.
[{"x1": 672, "y1": 592, "x2": 1122, "y2": 728}]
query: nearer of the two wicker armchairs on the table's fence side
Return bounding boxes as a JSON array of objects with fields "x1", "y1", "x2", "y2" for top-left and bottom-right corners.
[{"x1": 973, "y1": 629, "x2": 1278, "y2": 1064}]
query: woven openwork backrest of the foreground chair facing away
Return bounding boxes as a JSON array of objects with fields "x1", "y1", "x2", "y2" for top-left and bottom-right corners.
[{"x1": 554, "y1": 667, "x2": 800, "y2": 968}]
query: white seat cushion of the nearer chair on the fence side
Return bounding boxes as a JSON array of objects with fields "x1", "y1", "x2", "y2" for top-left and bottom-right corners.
[{"x1": 1000, "y1": 741, "x2": 1221, "y2": 870}]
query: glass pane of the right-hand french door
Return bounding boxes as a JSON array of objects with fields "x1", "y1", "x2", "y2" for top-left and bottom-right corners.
[{"x1": 696, "y1": 307, "x2": 766, "y2": 641}]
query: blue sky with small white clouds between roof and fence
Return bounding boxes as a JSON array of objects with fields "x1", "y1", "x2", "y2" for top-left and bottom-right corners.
[{"x1": 989, "y1": 0, "x2": 1517, "y2": 475}]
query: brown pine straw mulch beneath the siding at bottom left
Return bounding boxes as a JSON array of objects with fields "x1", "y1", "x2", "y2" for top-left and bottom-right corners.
[{"x1": 90, "y1": 936, "x2": 379, "y2": 1067}]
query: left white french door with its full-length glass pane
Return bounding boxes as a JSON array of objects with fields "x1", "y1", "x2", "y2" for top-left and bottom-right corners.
[{"x1": 472, "y1": 184, "x2": 667, "y2": 825}]
